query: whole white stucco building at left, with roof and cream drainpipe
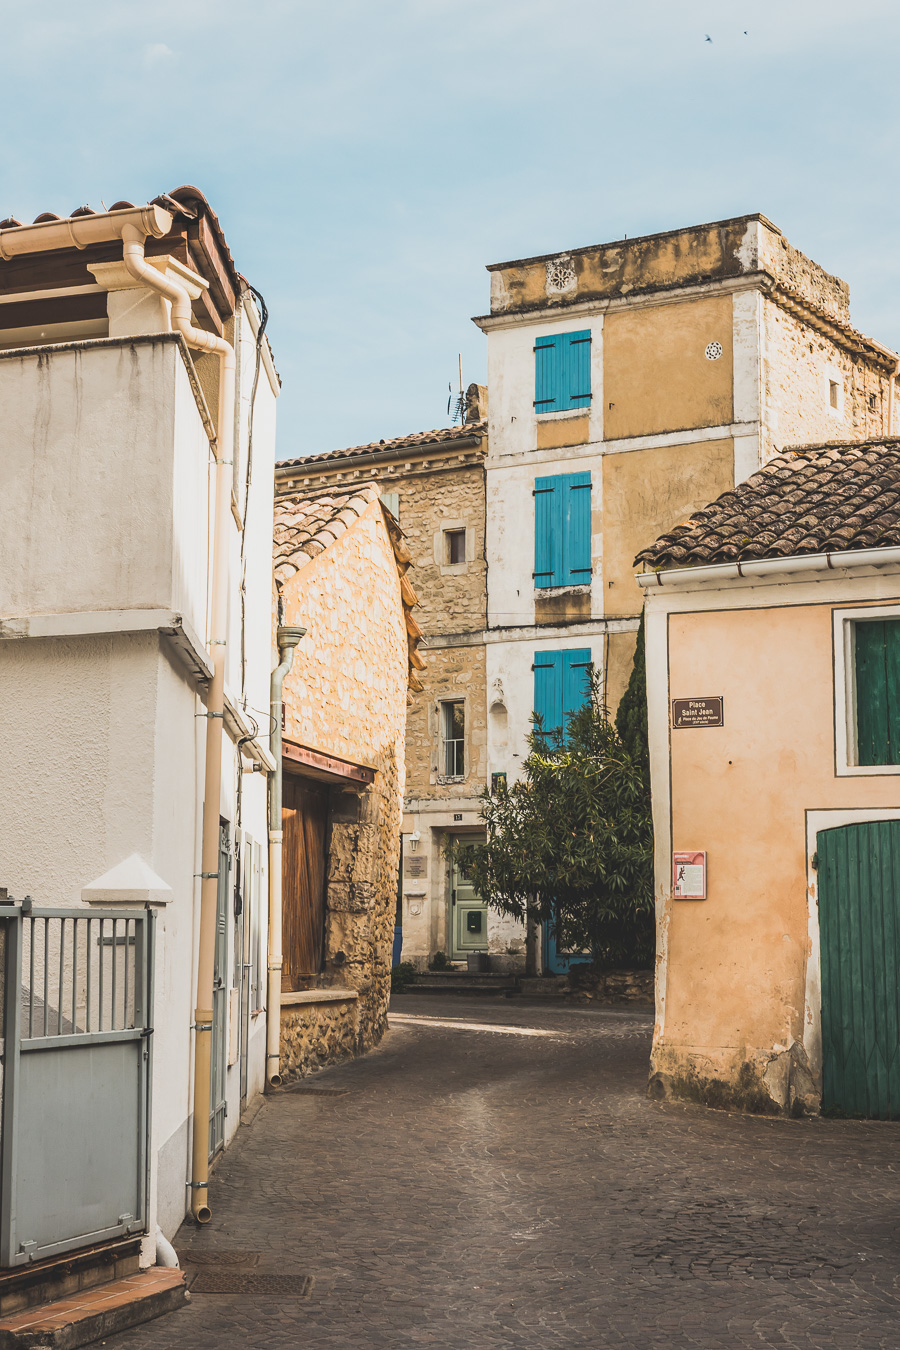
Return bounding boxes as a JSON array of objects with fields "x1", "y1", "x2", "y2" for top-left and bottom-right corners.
[{"x1": 0, "y1": 189, "x2": 278, "y2": 1262}]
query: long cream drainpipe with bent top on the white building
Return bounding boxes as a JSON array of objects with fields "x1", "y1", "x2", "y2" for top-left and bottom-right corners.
[{"x1": 121, "y1": 223, "x2": 235, "y2": 1223}]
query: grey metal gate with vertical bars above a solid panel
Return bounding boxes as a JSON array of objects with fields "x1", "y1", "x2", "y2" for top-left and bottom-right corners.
[{"x1": 0, "y1": 900, "x2": 155, "y2": 1266}]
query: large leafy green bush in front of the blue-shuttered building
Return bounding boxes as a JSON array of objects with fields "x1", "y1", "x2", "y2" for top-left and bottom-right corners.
[{"x1": 466, "y1": 671, "x2": 654, "y2": 968}]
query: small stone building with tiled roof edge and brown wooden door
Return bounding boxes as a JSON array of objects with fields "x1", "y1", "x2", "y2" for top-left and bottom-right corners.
[{"x1": 275, "y1": 483, "x2": 424, "y2": 1076}]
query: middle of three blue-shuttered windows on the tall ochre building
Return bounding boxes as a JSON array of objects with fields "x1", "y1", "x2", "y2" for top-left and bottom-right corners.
[{"x1": 534, "y1": 473, "x2": 591, "y2": 587}]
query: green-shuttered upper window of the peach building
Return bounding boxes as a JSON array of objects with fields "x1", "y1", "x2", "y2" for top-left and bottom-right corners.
[{"x1": 854, "y1": 618, "x2": 900, "y2": 764}]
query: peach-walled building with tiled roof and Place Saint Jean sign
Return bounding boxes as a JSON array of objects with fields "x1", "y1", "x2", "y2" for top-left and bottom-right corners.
[{"x1": 638, "y1": 437, "x2": 900, "y2": 1119}]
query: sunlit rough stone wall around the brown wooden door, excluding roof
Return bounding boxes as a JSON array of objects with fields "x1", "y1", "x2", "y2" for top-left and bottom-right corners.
[{"x1": 282, "y1": 502, "x2": 407, "y2": 1076}]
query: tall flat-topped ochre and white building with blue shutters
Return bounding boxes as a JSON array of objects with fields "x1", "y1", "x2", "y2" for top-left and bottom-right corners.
[{"x1": 475, "y1": 215, "x2": 897, "y2": 969}]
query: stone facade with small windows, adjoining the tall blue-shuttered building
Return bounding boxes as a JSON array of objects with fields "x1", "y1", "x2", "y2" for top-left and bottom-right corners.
[{"x1": 275, "y1": 407, "x2": 524, "y2": 968}]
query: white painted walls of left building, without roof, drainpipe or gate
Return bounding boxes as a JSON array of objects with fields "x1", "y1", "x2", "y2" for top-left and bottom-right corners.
[{"x1": 0, "y1": 315, "x2": 275, "y2": 1253}]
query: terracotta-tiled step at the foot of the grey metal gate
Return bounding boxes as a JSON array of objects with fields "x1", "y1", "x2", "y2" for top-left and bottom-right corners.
[{"x1": 0, "y1": 1266, "x2": 190, "y2": 1350}]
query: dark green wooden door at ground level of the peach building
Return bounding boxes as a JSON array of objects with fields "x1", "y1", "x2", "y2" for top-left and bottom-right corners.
[{"x1": 816, "y1": 821, "x2": 900, "y2": 1121}]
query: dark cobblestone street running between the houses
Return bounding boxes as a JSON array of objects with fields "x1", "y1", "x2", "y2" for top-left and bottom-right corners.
[{"x1": 105, "y1": 995, "x2": 900, "y2": 1350}]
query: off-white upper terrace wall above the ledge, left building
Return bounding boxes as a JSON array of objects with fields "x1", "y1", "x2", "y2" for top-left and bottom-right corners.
[{"x1": 0, "y1": 338, "x2": 208, "y2": 633}]
